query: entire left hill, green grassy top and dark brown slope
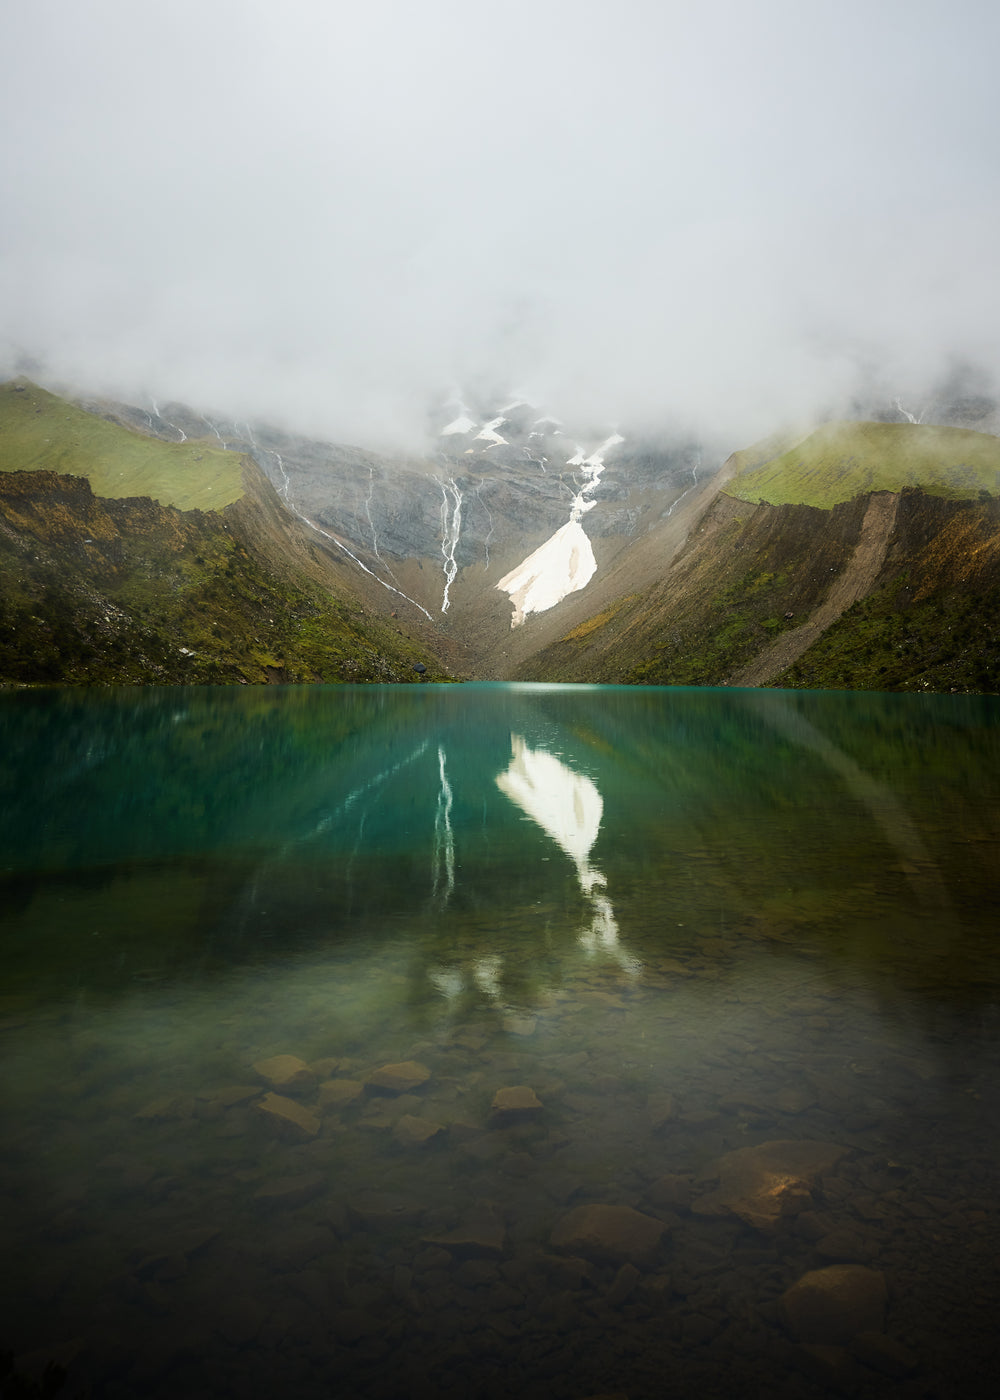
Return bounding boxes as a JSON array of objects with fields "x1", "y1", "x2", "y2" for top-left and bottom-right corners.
[{"x1": 0, "y1": 384, "x2": 445, "y2": 685}]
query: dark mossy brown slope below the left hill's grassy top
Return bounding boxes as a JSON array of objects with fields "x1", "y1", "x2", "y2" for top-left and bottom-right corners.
[{"x1": 0, "y1": 472, "x2": 443, "y2": 685}]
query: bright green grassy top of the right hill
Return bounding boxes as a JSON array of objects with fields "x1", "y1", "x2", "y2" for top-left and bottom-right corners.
[{"x1": 724, "y1": 423, "x2": 1000, "y2": 510}]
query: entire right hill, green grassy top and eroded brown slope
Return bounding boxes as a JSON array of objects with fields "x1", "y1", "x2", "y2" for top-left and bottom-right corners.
[{"x1": 517, "y1": 423, "x2": 1000, "y2": 692}]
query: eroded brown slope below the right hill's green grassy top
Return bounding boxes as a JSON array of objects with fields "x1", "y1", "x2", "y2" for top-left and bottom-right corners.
[{"x1": 518, "y1": 490, "x2": 1000, "y2": 692}]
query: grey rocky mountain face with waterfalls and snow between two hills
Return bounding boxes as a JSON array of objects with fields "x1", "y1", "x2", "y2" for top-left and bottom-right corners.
[{"x1": 87, "y1": 389, "x2": 708, "y2": 678}]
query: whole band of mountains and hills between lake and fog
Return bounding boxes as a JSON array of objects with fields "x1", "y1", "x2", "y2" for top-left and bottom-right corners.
[{"x1": 0, "y1": 379, "x2": 1000, "y2": 692}]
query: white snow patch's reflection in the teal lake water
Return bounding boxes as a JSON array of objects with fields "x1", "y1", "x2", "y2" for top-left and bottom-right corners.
[{"x1": 497, "y1": 734, "x2": 641, "y2": 973}]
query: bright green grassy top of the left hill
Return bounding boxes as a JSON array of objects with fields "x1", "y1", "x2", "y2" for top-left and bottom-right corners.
[{"x1": 0, "y1": 379, "x2": 244, "y2": 511}]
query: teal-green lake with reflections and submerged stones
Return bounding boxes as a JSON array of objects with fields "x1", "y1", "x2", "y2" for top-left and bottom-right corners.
[{"x1": 0, "y1": 686, "x2": 1000, "y2": 1400}]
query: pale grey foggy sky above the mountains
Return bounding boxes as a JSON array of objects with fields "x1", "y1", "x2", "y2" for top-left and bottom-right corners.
[{"x1": 0, "y1": 0, "x2": 1000, "y2": 447}]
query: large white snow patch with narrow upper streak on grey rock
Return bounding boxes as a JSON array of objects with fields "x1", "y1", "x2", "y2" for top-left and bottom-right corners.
[{"x1": 497, "y1": 433, "x2": 625, "y2": 627}]
